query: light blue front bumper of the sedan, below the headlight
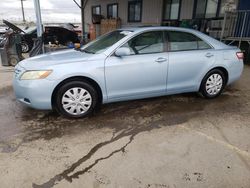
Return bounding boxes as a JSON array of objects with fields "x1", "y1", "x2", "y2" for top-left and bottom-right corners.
[{"x1": 13, "y1": 72, "x2": 56, "y2": 110}]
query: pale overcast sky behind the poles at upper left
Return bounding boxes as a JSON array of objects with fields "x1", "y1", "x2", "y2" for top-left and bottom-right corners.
[{"x1": 0, "y1": 0, "x2": 81, "y2": 23}]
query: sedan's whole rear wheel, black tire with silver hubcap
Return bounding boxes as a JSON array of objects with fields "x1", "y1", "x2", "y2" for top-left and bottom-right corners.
[{"x1": 200, "y1": 69, "x2": 226, "y2": 99}]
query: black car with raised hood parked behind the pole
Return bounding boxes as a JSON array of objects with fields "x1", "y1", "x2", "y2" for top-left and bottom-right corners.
[{"x1": 3, "y1": 20, "x2": 80, "y2": 53}]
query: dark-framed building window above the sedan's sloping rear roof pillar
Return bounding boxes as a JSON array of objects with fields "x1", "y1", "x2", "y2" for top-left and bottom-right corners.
[{"x1": 194, "y1": 0, "x2": 218, "y2": 18}]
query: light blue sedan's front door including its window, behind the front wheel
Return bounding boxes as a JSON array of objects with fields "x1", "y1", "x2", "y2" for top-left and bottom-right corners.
[{"x1": 105, "y1": 31, "x2": 168, "y2": 101}]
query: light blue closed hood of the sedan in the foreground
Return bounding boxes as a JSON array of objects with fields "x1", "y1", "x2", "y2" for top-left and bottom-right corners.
[{"x1": 18, "y1": 49, "x2": 95, "y2": 70}]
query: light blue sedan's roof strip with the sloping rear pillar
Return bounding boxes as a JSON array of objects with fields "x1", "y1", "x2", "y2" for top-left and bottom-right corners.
[{"x1": 119, "y1": 26, "x2": 231, "y2": 49}]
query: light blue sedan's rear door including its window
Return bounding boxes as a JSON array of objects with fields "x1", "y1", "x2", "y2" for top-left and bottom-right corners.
[{"x1": 166, "y1": 31, "x2": 216, "y2": 94}]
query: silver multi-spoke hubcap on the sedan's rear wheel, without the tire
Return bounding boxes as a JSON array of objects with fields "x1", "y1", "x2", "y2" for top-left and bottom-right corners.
[{"x1": 206, "y1": 74, "x2": 223, "y2": 95}]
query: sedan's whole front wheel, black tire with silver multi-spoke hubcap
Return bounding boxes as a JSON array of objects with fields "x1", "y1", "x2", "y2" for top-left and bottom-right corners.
[{"x1": 55, "y1": 81, "x2": 98, "y2": 118}]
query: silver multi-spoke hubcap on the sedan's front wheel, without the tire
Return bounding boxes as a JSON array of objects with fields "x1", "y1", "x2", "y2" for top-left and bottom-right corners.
[{"x1": 62, "y1": 87, "x2": 92, "y2": 115}]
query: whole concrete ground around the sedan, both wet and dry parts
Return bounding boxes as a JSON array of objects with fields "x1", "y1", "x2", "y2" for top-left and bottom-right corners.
[{"x1": 0, "y1": 62, "x2": 250, "y2": 188}]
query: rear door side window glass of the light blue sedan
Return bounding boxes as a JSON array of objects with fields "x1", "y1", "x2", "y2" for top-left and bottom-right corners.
[{"x1": 167, "y1": 31, "x2": 211, "y2": 51}]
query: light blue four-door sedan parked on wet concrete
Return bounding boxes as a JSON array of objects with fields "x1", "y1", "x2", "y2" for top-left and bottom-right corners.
[{"x1": 13, "y1": 27, "x2": 243, "y2": 118}]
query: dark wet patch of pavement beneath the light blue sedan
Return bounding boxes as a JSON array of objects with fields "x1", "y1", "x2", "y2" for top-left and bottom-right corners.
[{"x1": 0, "y1": 86, "x2": 246, "y2": 150}]
